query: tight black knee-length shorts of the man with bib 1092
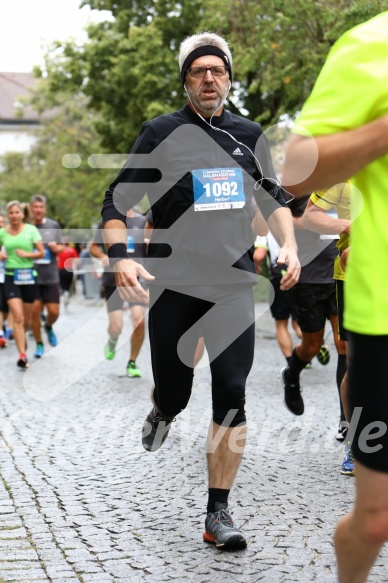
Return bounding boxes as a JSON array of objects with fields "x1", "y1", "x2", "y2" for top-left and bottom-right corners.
[{"x1": 148, "y1": 285, "x2": 255, "y2": 427}]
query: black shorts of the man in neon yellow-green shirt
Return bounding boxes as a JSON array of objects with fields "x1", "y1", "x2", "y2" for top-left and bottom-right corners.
[{"x1": 348, "y1": 332, "x2": 388, "y2": 473}]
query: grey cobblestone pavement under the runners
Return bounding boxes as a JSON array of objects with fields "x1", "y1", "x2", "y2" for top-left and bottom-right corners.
[{"x1": 0, "y1": 299, "x2": 388, "y2": 583}]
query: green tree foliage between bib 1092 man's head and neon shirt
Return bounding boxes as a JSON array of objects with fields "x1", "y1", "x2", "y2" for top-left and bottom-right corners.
[{"x1": 207, "y1": 0, "x2": 388, "y2": 126}]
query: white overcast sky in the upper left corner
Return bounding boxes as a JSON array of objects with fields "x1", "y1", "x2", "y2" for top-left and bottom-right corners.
[{"x1": 0, "y1": 0, "x2": 110, "y2": 73}]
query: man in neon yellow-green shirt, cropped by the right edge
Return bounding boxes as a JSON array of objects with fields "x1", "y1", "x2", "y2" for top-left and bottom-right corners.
[{"x1": 283, "y1": 12, "x2": 388, "y2": 583}]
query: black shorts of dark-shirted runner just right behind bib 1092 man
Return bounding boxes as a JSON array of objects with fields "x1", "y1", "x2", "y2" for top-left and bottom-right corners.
[{"x1": 286, "y1": 282, "x2": 337, "y2": 333}]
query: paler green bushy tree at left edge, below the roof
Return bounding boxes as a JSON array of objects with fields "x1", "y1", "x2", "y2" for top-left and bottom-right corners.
[{"x1": 0, "y1": 89, "x2": 116, "y2": 228}]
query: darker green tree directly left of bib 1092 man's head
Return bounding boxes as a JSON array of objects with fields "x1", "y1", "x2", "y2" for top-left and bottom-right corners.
[{"x1": 36, "y1": 0, "x2": 202, "y2": 152}]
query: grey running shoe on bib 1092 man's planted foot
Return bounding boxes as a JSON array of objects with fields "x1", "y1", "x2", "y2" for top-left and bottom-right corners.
[{"x1": 203, "y1": 508, "x2": 247, "y2": 551}]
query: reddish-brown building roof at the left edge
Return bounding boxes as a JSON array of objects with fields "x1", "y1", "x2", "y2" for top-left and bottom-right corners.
[{"x1": 0, "y1": 73, "x2": 40, "y2": 124}]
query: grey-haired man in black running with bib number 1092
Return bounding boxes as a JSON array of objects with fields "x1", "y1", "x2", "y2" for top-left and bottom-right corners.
[{"x1": 102, "y1": 33, "x2": 299, "y2": 550}]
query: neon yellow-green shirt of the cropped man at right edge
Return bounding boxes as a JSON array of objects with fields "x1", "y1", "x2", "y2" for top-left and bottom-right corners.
[{"x1": 293, "y1": 12, "x2": 388, "y2": 335}]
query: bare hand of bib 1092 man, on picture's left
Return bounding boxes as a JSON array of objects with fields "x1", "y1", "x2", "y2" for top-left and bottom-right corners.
[{"x1": 113, "y1": 259, "x2": 155, "y2": 304}]
